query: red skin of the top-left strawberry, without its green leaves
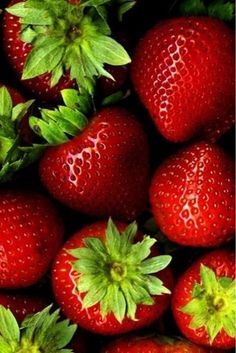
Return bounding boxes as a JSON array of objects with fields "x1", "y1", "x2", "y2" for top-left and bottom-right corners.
[{"x1": 2, "y1": 0, "x2": 75, "y2": 102}]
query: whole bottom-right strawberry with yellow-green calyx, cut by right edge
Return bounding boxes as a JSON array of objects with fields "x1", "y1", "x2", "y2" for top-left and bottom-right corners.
[{"x1": 172, "y1": 249, "x2": 236, "y2": 349}]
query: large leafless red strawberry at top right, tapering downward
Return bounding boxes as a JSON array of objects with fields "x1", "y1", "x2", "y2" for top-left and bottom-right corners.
[{"x1": 131, "y1": 17, "x2": 235, "y2": 142}]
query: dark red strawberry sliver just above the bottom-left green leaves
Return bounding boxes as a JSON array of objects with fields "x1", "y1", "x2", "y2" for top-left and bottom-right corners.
[{"x1": 0, "y1": 292, "x2": 49, "y2": 322}]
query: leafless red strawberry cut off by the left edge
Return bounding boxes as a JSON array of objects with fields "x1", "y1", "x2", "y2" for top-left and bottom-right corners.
[{"x1": 0, "y1": 190, "x2": 63, "y2": 288}]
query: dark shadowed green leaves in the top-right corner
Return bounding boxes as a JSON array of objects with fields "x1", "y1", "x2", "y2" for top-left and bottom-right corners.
[{"x1": 179, "y1": 0, "x2": 235, "y2": 22}]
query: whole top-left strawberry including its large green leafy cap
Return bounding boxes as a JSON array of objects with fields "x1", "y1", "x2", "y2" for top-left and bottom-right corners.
[{"x1": 3, "y1": 0, "x2": 130, "y2": 101}]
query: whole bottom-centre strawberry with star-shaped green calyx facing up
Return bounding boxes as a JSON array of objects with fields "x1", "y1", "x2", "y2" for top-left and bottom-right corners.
[{"x1": 52, "y1": 219, "x2": 172, "y2": 335}]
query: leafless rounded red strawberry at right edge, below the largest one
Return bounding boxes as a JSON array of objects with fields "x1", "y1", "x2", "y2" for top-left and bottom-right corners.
[{"x1": 150, "y1": 142, "x2": 235, "y2": 247}]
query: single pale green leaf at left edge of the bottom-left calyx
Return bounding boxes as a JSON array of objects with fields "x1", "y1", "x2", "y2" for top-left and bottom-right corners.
[{"x1": 0, "y1": 305, "x2": 20, "y2": 342}]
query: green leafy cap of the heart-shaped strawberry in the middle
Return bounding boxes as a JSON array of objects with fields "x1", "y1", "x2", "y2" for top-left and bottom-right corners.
[{"x1": 29, "y1": 89, "x2": 92, "y2": 145}]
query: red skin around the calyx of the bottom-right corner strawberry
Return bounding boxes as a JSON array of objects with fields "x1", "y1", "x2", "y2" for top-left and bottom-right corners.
[{"x1": 172, "y1": 249, "x2": 235, "y2": 349}]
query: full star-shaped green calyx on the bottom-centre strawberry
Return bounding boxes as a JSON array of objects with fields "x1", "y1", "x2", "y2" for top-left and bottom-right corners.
[{"x1": 68, "y1": 219, "x2": 171, "y2": 323}]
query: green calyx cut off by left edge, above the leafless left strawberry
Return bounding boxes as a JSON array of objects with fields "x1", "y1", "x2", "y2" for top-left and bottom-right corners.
[{"x1": 0, "y1": 86, "x2": 45, "y2": 182}]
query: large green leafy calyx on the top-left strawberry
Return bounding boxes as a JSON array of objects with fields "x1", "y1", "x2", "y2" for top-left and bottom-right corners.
[{"x1": 6, "y1": 0, "x2": 130, "y2": 94}]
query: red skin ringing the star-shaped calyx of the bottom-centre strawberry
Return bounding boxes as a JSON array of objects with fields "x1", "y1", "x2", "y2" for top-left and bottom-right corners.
[{"x1": 52, "y1": 222, "x2": 173, "y2": 335}]
